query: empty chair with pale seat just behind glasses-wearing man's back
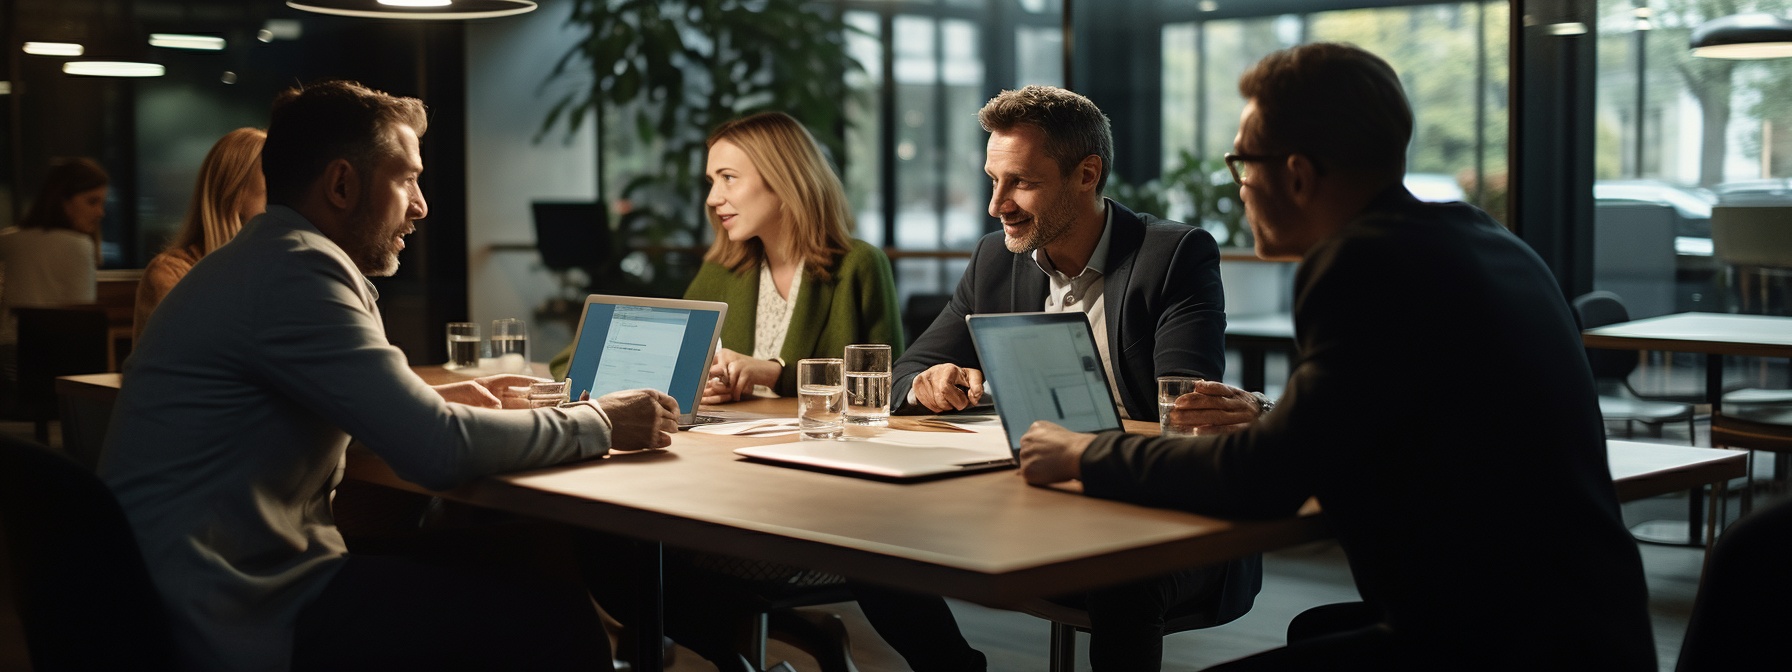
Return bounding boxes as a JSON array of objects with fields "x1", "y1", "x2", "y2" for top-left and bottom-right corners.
[{"x1": 1573, "y1": 290, "x2": 1695, "y2": 443}]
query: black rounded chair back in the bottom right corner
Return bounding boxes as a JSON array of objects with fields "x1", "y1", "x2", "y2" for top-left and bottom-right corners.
[{"x1": 1674, "y1": 500, "x2": 1792, "y2": 672}]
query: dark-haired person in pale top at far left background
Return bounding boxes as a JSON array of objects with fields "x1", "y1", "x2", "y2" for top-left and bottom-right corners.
[{"x1": 0, "y1": 158, "x2": 111, "y2": 389}]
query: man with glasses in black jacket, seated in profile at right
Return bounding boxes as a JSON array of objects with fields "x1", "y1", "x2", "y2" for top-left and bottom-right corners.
[{"x1": 1021, "y1": 43, "x2": 1656, "y2": 670}]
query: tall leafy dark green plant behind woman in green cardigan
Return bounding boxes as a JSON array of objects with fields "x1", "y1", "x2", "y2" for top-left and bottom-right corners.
[{"x1": 538, "y1": 0, "x2": 864, "y2": 290}]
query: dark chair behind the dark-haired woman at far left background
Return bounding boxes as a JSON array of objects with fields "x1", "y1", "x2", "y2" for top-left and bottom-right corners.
[{"x1": 11, "y1": 305, "x2": 111, "y2": 443}]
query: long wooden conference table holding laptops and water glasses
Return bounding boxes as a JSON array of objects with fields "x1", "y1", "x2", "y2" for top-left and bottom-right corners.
[{"x1": 57, "y1": 367, "x2": 1744, "y2": 668}]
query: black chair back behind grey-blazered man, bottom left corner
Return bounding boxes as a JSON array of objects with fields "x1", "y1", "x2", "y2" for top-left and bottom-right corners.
[{"x1": 0, "y1": 435, "x2": 176, "y2": 672}]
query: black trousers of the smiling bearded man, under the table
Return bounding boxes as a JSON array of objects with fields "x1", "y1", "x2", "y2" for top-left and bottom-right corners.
[{"x1": 853, "y1": 564, "x2": 1226, "y2": 672}]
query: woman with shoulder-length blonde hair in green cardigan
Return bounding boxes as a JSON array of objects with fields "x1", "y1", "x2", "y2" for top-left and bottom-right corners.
[{"x1": 550, "y1": 111, "x2": 903, "y2": 397}]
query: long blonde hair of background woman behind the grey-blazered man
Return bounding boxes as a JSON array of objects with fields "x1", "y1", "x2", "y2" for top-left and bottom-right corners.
[{"x1": 168, "y1": 129, "x2": 267, "y2": 256}]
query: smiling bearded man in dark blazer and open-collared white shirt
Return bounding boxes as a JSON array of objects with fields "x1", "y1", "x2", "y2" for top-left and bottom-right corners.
[{"x1": 855, "y1": 86, "x2": 1262, "y2": 672}]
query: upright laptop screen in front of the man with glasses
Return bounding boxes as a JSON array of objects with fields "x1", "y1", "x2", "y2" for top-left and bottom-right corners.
[{"x1": 964, "y1": 312, "x2": 1122, "y2": 455}]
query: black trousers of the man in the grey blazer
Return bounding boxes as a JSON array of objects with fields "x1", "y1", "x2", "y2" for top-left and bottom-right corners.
[{"x1": 292, "y1": 532, "x2": 611, "y2": 670}]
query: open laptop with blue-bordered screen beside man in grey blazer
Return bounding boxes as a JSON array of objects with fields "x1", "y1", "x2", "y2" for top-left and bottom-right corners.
[{"x1": 566, "y1": 294, "x2": 737, "y2": 428}]
